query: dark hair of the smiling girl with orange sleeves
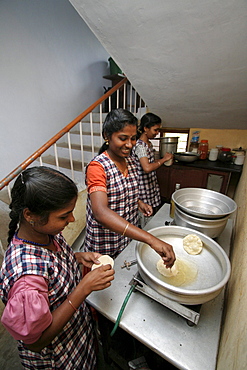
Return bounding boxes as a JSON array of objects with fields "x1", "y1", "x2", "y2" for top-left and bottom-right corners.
[{"x1": 99, "y1": 108, "x2": 138, "y2": 154}]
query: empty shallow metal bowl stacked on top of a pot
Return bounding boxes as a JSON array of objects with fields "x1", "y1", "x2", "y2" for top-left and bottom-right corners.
[{"x1": 172, "y1": 188, "x2": 237, "y2": 219}]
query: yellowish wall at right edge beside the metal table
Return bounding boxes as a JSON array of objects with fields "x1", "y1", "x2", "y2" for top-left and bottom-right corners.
[{"x1": 217, "y1": 161, "x2": 247, "y2": 370}]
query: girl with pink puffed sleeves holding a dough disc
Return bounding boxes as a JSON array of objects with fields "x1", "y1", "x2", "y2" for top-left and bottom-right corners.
[{"x1": 0, "y1": 167, "x2": 114, "y2": 370}]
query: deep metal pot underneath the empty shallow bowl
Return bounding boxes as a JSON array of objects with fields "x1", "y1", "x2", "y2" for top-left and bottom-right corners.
[{"x1": 174, "y1": 207, "x2": 229, "y2": 238}]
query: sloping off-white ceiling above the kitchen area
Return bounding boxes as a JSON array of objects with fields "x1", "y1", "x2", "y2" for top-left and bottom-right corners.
[{"x1": 70, "y1": 0, "x2": 247, "y2": 129}]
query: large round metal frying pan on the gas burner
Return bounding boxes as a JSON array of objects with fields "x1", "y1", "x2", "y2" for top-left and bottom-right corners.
[{"x1": 136, "y1": 226, "x2": 231, "y2": 305}]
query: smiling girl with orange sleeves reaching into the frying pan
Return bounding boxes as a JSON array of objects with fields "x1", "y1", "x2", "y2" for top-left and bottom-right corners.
[{"x1": 84, "y1": 109, "x2": 175, "y2": 267}]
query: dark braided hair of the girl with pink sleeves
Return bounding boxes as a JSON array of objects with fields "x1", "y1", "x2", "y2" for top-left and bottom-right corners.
[{"x1": 8, "y1": 166, "x2": 78, "y2": 243}]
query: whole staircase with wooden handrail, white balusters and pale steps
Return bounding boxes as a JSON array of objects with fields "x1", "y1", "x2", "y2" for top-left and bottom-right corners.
[{"x1": 0, "y1": 78, "x2": 147, "y2": 263}]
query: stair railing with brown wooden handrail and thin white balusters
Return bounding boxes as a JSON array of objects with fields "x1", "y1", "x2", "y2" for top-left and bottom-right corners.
[{"x1": 0, "y1": 77, "x2": 147, "y2": 196}]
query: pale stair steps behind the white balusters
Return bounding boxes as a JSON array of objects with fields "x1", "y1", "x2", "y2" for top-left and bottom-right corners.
[{"x1": 0, "y1": 112, "x2": 107, "y2": 253}]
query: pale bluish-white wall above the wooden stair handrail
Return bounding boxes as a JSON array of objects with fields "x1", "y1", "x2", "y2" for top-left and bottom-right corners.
[{"x1": 0, "y1": 0, "x2": 109, "y2": 180}]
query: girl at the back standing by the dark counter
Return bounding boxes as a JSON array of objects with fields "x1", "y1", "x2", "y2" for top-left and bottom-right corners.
[{"x1": 132, "y1": 113, "x2": 173, "y2": 214}]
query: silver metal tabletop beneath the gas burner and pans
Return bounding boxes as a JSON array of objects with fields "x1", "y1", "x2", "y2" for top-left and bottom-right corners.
[{"x1": 87, "y1": 204, "x2": 232, "y2": 370}]
